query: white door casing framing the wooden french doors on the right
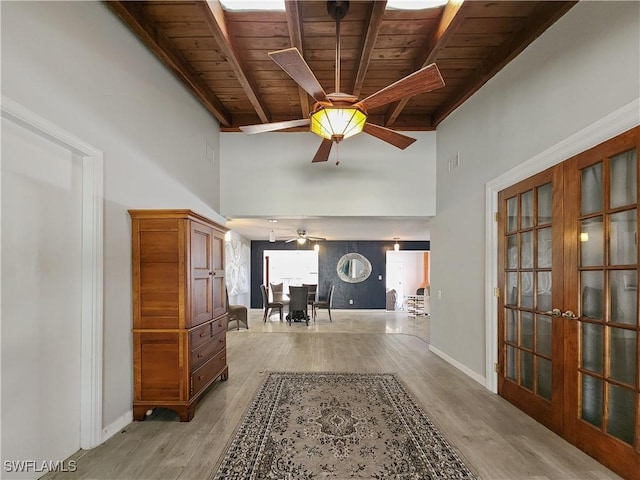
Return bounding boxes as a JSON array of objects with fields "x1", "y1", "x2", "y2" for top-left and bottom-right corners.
[{"x1": 485, "y1": 98, "x2": 640, "y2": 393}]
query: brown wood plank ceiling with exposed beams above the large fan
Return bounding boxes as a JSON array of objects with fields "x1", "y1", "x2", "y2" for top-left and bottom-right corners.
[{"x1": 106, "y1": 0, "x2": 576, "y2": 131}]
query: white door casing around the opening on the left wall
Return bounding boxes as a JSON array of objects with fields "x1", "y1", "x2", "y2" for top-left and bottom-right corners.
[{"x1": 1, "y1": 95, "x2": 104, "y2": 448}]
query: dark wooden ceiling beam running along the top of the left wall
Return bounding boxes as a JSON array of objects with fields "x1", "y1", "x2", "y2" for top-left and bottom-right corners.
[{"x1": 106, "y1": 1, "x2": 232, "y2": 127}]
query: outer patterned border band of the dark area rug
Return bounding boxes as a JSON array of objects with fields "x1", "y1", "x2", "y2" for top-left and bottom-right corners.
[{"x1": 207, "y1": 370, "x2": 482, "y2": 480}]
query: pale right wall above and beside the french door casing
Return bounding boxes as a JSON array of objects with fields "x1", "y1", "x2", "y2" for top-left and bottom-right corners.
[{"x1": 430, "y1": 1, "x2": 640, "y2": 376}]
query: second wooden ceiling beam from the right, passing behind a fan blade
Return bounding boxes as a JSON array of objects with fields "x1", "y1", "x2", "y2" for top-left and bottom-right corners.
[{"x1": 384, "y1": 0, "x2": 469, "y2": 127}]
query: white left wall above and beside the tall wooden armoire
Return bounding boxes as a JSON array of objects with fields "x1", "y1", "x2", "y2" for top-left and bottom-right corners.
[{"x1": 0, "y1": 2, "x2": 223, "y2": 427}]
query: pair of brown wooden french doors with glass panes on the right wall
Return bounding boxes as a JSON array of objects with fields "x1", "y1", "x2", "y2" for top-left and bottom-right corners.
[{"x1": 498, "y1": 127, "x2": 640, "y2": 478}]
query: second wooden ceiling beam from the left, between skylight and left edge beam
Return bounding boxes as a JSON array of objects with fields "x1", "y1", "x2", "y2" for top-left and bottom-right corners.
[{"x1": 196, "y1": 0, "x2": 271, "y2": 123}]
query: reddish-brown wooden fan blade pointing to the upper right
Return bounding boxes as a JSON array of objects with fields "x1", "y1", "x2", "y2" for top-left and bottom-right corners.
[{"x1": 356, "y1": 63, "x2": 444, "y2": 110}]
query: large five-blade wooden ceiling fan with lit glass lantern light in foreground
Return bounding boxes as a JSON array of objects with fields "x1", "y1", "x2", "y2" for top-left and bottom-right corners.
[{"x1": 240, "y1": 1, "x2": 444, "y2": 163}]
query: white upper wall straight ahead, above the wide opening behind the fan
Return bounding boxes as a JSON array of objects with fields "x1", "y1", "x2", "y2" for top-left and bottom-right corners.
[{"x1": 220, "y1": 132, "x2": 436, "y2": 216}]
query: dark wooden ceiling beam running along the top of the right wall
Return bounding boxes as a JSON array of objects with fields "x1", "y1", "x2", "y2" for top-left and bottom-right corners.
[{"x1": 433, "y1": 1, "x2": 578, "y2": 125}]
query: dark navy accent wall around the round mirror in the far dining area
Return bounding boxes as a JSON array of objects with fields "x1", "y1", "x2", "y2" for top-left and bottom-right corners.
[{"x1": 251, "y1": 240, "x2": 430, "y2": 309}]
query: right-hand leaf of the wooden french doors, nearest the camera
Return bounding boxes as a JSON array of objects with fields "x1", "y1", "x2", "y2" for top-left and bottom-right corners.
[{"x1": 564, "y1": 128, "x2": 640, "y2": 478}]
